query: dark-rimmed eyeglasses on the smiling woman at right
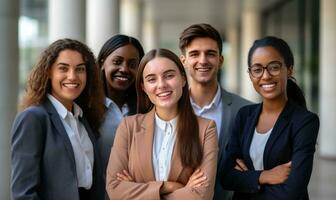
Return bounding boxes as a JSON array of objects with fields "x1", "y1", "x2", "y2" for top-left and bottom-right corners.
[{"x1": 248, "y1": 61, "x2": 282, "y2": 78}]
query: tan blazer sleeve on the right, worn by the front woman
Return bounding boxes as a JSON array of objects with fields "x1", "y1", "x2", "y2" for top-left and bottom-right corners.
[{"x1": 162, "y1": 121, "x2": 218, "y2": 200}]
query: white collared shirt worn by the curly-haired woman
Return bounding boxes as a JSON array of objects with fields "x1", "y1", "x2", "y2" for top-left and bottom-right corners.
[{"x1": 48, "y1": 94, "x2": 94, "y2": 189}]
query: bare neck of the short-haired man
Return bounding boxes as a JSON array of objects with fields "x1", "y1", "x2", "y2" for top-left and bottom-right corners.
[{"x1": 190, "y1": 81, "x2": 219, "y2": 107}]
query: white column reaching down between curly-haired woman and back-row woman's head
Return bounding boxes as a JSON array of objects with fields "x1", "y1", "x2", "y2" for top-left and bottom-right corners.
[{"x1": 86, "y1": 0, "x2": 120, "y2": 56}]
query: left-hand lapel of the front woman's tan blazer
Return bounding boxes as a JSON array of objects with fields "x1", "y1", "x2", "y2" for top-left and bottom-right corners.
[{"x1": 134, "y1": 109, "x2": 155, "y2": 181}]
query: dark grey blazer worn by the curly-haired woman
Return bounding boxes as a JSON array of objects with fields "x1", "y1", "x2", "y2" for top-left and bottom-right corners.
[{"x1": 11, "y1": 100, "x2": 104, "y2": 200}]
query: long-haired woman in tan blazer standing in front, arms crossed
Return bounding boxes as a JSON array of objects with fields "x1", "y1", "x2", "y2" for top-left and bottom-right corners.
[{"x1": 106, "y1": 49, "x2": 218, "y2": 199}]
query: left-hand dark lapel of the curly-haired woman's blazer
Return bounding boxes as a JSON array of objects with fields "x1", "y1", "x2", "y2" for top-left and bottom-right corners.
[{"x1": 43, "y1": 99, "x2": 76, "y2": 173}]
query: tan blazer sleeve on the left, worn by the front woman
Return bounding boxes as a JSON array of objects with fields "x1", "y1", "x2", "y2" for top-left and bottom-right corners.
[{"x1": 106, "y1": 119, "x2": 162, "y2": 200}]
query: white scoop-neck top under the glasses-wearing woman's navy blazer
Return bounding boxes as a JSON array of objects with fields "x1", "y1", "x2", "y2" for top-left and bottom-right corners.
[{"x1": 250, "y1": 128, "x2": 273, "y2": 170}]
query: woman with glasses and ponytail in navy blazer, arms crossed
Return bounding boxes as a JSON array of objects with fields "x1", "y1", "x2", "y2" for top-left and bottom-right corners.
[{"x1": 221, "y1": 36, "x2": 319, "y2": 200}]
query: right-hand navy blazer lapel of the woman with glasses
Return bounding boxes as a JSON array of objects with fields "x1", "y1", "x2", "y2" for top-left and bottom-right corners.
[{"x1": 263, "y1": 101, "x2": 293, "y2": 169}]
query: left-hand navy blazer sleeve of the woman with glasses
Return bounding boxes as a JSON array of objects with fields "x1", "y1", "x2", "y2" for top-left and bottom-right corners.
[{"x1": 218, "y1": 110, "x2": 261, "y2": 193}]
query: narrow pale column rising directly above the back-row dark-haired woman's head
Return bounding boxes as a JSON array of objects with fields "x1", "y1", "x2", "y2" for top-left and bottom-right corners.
[{"x1": 120, "y1": 0, "x2": 142, "y2": 40}]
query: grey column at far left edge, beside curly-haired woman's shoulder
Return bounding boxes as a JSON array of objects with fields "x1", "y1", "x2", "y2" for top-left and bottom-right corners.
[{"x1": 0, "y1": 0, "x2": 19, "y2": 199}]
